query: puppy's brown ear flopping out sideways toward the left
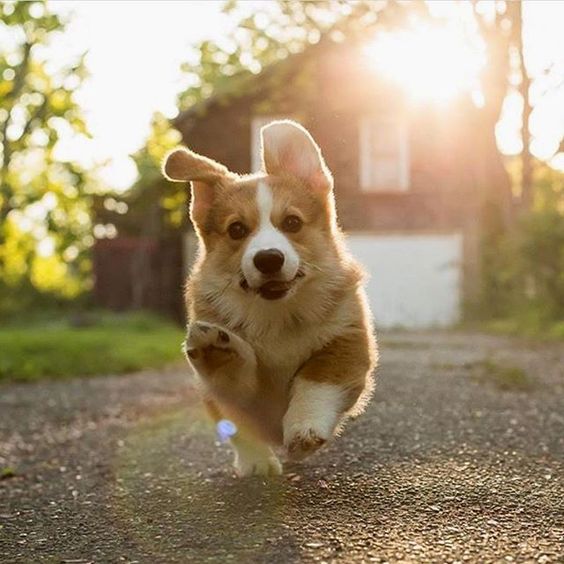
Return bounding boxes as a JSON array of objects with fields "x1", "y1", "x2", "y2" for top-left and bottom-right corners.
[{"x1": 163, "y1": 147, "x2": 232, "y2": 223}]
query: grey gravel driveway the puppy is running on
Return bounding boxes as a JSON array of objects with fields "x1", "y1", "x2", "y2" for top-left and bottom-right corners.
[{"x1": 0, "y1": 333, "x2": 564, "y2": 563}]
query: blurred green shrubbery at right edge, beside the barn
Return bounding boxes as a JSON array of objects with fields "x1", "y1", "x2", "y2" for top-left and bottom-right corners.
[{"x1": 476, "y1": 167, "x2": 564, "y2": 332}]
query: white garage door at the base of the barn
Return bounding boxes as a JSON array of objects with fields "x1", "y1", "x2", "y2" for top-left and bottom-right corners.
[{"x1": 347, "y1": 233, "x2": 462, "y2": 328}]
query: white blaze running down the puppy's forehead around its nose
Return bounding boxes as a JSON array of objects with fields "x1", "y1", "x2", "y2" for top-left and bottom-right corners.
[{"x1": 241, "y1": 182, "x2": 300, "y2": 288}]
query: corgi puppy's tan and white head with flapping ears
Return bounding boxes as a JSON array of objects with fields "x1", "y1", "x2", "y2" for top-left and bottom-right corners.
[{"x1": 163, "y1": 121, "x2": 337, "y2": 300}]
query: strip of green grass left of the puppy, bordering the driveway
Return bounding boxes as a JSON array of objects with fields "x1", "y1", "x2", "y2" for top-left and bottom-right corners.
[{"x1": 0, "y1": 313, "x2": 183, "y2": 382}]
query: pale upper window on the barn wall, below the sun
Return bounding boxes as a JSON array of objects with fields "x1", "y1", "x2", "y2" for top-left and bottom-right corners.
[{"x1": 360, "y1": 116, "x2": 409, "y2": 192}]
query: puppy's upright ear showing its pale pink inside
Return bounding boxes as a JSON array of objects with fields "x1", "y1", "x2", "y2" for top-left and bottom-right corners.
[{"x1": 261, "y1": 120, "x2": 333, "y2": 192}]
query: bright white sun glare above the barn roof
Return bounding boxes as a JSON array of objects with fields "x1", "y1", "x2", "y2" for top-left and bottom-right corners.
[{"x1": 365, "y1": 27, "x2": 483, "y2": 102}]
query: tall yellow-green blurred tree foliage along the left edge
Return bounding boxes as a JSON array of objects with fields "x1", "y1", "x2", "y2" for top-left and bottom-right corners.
[{"x1": 0, "y1": 1, "x2": 93, "y2": 311}]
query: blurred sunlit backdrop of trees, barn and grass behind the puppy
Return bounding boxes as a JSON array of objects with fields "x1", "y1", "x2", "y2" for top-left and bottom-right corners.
[{"x1": 0, "y1": 0, "x2": 564, "y2": 380}]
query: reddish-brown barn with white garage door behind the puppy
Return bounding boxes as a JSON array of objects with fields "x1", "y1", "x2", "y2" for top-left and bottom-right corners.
[{"x1": 171, "y1": 40, "x2": 506, "y2": 327}]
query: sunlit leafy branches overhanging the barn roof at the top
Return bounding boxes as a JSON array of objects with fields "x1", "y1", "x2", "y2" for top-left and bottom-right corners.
[{"x1": 178, "y1": 0, "x2": 420, "y2": 110}]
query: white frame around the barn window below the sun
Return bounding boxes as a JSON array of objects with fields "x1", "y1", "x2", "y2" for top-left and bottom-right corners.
[{"x1": 359, "y1": 115, "x2": 410, "y2": 193}]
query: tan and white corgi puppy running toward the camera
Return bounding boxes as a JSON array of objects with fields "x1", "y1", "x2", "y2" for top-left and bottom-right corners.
[{"x1": 163, "y1": 120, "x2": 378, "y2": 476}]
